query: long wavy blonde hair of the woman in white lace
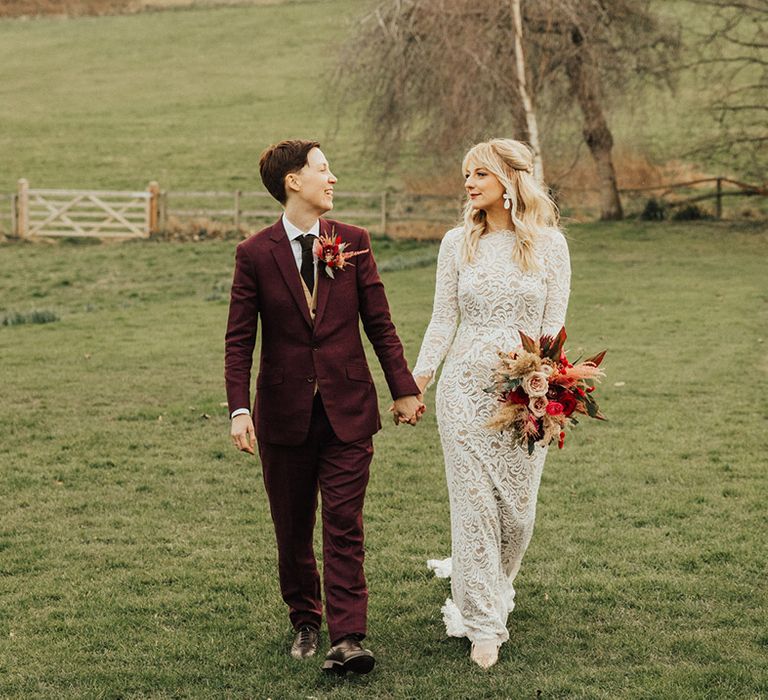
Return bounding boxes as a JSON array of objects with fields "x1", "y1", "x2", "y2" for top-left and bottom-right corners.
[{"x1": 461, "y1": 139, "x2": 560, "y2": 272}]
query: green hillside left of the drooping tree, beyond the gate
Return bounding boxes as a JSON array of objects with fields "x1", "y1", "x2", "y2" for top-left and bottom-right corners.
[{"x1": 0, "y1": 0, "x2": 372, "y2": 191}]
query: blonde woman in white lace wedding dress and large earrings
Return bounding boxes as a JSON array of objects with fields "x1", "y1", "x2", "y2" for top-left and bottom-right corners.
[{"x1": 413, "y1": 139, "x2": 571, "y2": 668}]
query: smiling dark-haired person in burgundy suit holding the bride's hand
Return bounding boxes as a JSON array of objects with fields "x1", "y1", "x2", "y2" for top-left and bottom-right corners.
[{"x1": 225, "y1": 140, "x2": 423, "y2": 674}]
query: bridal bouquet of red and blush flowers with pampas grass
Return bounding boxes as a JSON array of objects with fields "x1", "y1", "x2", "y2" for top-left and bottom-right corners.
[{"x1": 484, "y1": 328, "x2": 606, "y2": 454}]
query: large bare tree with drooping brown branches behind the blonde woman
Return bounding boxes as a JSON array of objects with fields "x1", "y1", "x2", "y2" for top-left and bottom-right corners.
[{"x1": 341, "y1": 0, "x2": 677, "y2": 219}]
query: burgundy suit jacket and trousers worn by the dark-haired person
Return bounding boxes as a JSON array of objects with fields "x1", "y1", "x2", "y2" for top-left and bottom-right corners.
[{"x1": 225, "y1": 219, "x2": 419, "y2": 641}]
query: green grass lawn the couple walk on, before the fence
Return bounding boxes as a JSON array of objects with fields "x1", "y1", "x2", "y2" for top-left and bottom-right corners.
[{"x1": 0, "y1": 224, "x2": 768, "y2": 700}]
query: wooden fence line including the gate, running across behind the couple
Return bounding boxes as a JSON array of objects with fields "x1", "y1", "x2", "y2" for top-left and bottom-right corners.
[{"x1": 0, "y1": 177, "x2": 768, "y2": 238}]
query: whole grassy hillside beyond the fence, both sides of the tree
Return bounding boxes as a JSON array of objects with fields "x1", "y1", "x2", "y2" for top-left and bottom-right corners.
[{"x1": 0, "y1": 0, "x2": 748, "y2": 209}]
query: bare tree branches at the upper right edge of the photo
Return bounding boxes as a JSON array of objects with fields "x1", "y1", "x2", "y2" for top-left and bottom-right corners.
[{"x1": 692, "y1": 0, "x2": 768, "y2": 182}]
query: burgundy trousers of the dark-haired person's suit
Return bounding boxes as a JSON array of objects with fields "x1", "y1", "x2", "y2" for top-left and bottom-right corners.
[{"x1": 259, "y1": 393, "x2": 373, "y2": 643}]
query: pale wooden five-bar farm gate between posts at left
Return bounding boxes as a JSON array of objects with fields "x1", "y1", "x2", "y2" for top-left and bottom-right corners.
[{"x1": 14, "y1": 180, "x2": 159, "y2": 239}]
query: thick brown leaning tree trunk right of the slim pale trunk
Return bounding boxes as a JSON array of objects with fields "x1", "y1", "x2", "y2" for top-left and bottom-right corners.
[{"x1": 566, "y1": 29, "x2": 624, "y2": 221}]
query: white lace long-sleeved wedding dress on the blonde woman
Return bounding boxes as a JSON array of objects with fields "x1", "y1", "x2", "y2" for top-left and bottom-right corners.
[{"x1": 413, "y1": 228, "x2": 571, "y2": 644}]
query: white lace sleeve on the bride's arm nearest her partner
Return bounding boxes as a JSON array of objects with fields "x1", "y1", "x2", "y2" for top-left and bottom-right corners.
[{"x1": 413, "y1": 229, "x2": 461, "y2": 386}]
